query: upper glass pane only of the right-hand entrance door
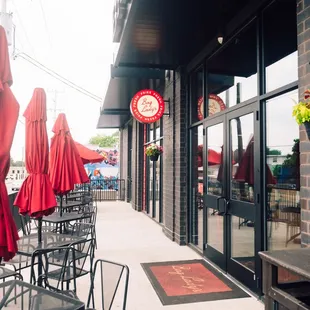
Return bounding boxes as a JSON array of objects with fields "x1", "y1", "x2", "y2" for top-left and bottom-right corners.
[{"x1": 230, "y1": 113, "x2": 254, "y2": 202}]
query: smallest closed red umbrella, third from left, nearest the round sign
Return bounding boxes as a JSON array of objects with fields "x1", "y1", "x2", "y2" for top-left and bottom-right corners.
[{"x1": 49, "y1": 113, "x2": 89, "y2": 195}]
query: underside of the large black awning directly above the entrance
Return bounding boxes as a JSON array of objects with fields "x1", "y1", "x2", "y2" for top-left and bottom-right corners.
[{"x1": 114, "y1": 0, "x2": 261, "y2": 69}]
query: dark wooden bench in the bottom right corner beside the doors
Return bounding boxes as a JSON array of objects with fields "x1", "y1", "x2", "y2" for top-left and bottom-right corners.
[{"x1": 259, "y1": 249, "x2": 310, "y2": 310}]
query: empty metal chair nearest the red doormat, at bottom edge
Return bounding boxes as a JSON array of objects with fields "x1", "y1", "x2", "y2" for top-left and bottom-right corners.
[{"x1": 87, "y1": 259, "x2": 129, "y2": 310}]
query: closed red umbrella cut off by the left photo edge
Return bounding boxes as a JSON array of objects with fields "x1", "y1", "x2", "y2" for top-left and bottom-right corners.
[{"x1": 0, "y1": 26, "x2": 19, "y2": 261}]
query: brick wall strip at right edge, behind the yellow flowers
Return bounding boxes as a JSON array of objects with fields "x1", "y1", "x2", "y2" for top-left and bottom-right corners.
[{"x1": 297, "y1": 0, "x2": 310, "y2": 247}]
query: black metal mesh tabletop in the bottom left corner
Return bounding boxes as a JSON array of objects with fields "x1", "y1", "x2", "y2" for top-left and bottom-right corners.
[{"x1": 0, "y1": 280, "x2": 85, "y2": 310}]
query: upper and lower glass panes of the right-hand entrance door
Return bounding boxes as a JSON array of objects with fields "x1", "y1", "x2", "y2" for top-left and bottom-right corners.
[{"x1": 230, "y1": 113, "x2": 255, "y2": 270}]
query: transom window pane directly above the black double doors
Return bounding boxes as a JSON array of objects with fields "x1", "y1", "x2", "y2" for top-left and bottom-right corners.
[{"x1": 207, "y1": 22, "x2": 257, "y2": 108}]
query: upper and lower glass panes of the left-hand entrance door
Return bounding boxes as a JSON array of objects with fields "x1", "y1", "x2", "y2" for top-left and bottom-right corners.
[{"x1": 206, "y1": 123, "x2": 224, "y2": 253}]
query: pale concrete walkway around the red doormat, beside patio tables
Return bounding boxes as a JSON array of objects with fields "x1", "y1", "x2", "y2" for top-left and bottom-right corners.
[{"x1": 88, "y1": 202, "x2": 264, "y2": 310}]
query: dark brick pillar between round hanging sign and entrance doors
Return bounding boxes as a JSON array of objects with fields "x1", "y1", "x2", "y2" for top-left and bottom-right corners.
[{"x1": 163, "y1": 69, "x2": 188, "y2": 245}]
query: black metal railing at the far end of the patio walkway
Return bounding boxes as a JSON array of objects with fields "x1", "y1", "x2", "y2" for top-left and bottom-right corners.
[{"x1": 90, "y1": 179, "x2": 126, "y2": 201}]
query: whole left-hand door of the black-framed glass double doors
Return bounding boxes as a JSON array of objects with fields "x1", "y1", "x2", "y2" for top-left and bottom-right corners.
[{"x1": 204, "y1": 116, "x2": 227, "y2": 270}]
